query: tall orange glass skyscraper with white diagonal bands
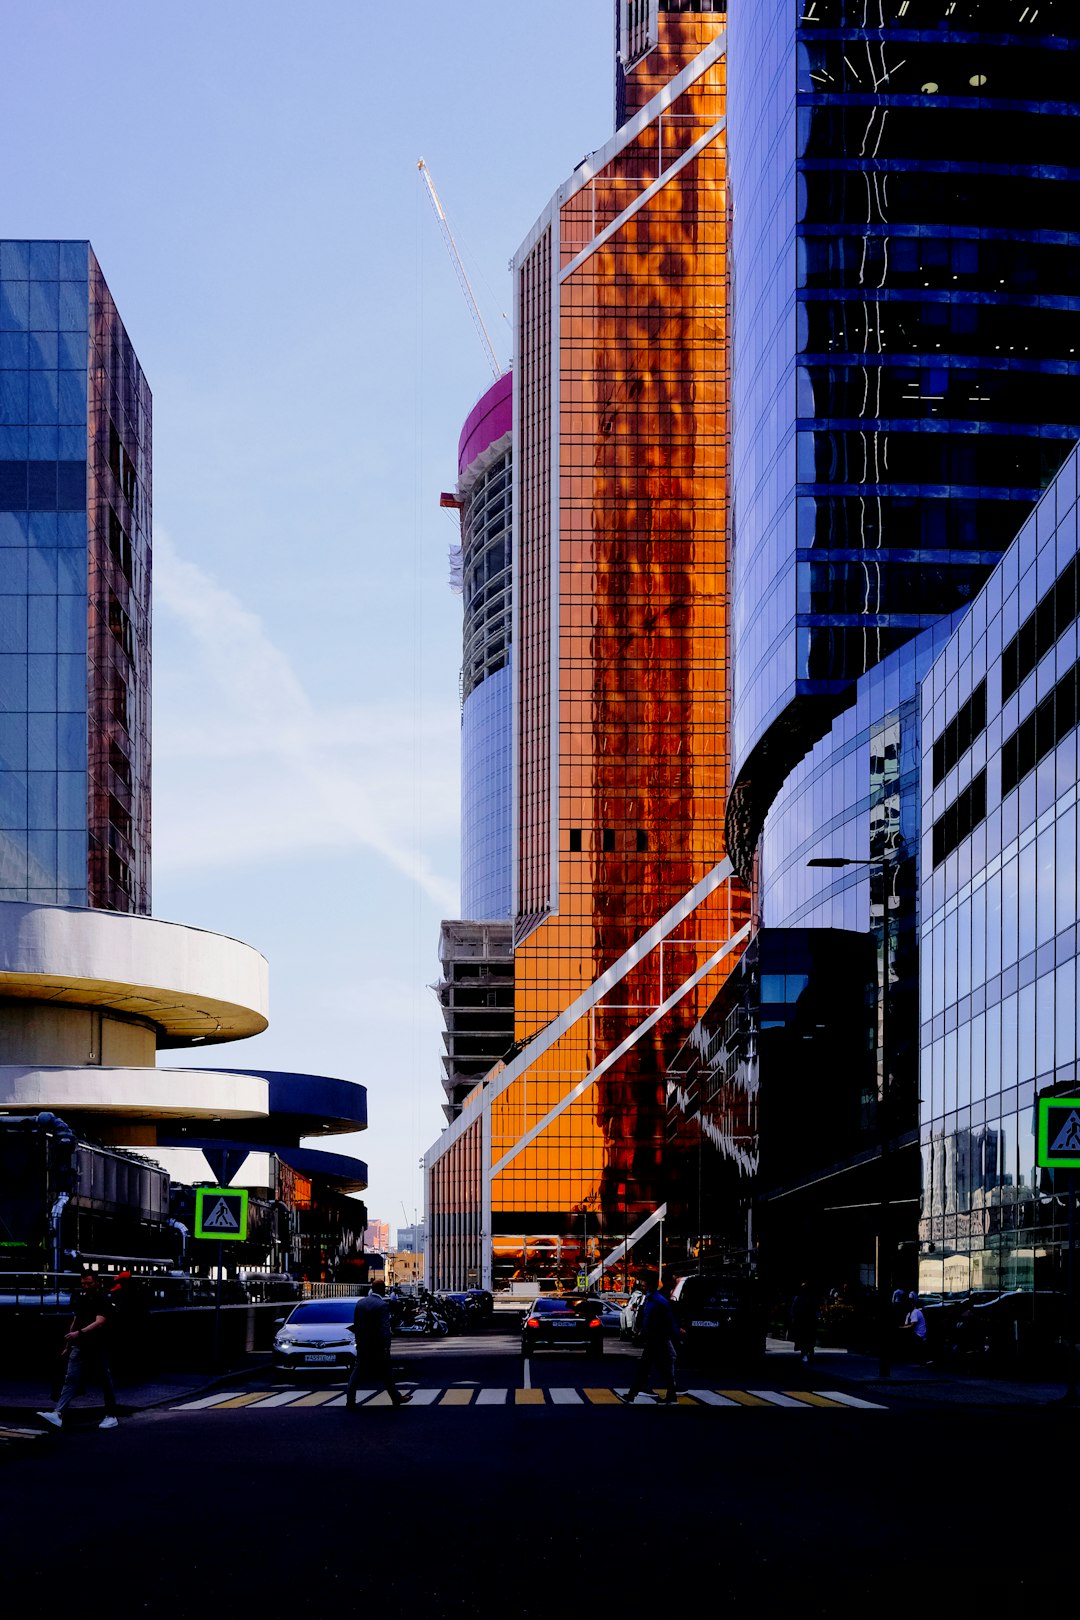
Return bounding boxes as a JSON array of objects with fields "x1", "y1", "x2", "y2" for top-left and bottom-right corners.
[{"x1": 427, "y1": 0, "x2": 746, "y2": 1286}]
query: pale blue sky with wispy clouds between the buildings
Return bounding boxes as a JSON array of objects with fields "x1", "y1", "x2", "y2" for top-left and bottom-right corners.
[{"x1": 0, "y1": 0, "x2": 614, "y2": 1231}]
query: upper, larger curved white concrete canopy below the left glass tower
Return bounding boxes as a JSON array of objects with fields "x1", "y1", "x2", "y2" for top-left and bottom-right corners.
[{"x1": 0, "y1": 901, "x2": 269, "y2": 1047}]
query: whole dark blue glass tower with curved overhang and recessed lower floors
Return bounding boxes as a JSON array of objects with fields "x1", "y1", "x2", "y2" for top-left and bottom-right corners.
[{"x1": 714, "y1": 0, "x2": 1080, "y2": 1285}]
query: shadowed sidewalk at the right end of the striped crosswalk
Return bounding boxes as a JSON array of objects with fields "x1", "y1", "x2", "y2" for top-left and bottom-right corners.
[{"x1": 767, "y1": 1340, "x2": 1065, "y2": 1406}]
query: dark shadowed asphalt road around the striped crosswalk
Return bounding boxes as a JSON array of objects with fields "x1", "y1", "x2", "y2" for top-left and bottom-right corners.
[{"x1": 8, "y1": 1335, "x2": 1077, "y2": 1620}]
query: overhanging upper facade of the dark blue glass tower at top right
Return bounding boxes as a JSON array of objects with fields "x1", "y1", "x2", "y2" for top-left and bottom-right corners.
[{"x1": 729, "y1": 0, "x2": 1080, "y2": 870}]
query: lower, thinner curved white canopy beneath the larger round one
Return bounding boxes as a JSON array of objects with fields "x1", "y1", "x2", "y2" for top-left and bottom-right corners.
[{"x1": 0, "y1": 1064, "x2": 270, "y2": 1121}]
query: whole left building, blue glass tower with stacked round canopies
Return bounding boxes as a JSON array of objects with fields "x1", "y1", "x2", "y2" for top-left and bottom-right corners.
[{"x1": 0, "y1": 241, "x2": 366, "y2": 1276}]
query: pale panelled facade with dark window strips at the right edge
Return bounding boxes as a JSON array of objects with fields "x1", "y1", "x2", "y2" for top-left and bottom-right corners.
[{"x1": 918, "y1": 449, "x2": 1080, "y2": 1301}]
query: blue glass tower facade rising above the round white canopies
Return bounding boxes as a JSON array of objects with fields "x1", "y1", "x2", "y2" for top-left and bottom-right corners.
[{"x1": 0, "y1": 241, "x2": 151, "y2": 912}]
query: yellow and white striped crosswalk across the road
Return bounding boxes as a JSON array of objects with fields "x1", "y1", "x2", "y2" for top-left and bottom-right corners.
[{"x1": 172, "y1": 1383, "x2": 887, "y2": 1413}]
